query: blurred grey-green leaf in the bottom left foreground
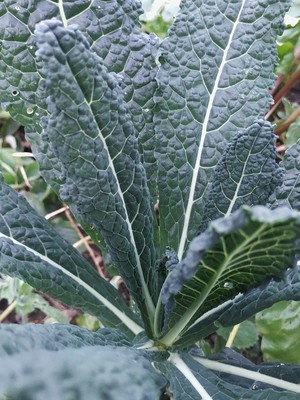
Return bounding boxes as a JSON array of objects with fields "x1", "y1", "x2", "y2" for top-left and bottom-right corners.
[{"x1": 0, "y1": 346, "x2": 164, "y2": 400}]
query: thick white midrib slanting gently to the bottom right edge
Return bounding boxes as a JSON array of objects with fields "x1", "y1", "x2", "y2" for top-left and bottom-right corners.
[{"x1": 193, "y1": 357, "x2": 300, "y2": 393}]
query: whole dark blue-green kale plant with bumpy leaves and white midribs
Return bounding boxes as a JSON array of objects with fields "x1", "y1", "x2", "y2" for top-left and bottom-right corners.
[{"x1": 0, "y1": 0, "x2": 300, "y2": 400}]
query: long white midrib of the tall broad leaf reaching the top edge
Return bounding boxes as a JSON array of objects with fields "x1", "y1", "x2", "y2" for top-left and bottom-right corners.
[{"x1": 177, "y1": 0, "x2": 246, "y2": 260}]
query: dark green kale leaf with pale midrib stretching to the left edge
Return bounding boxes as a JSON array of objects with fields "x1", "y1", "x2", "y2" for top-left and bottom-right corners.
[{"x1": 0, "y1": 178, "x2": 143, "y2": 335}]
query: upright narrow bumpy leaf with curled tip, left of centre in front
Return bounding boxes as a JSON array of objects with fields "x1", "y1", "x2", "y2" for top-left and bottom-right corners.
[{"x1": 36, "y1": 20, "x2": 157, "y2": 332}]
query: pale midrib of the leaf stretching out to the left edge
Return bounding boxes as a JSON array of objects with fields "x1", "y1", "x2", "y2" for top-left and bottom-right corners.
[{"x1": 0, "y1": 232, "x2": 144, "y2": 335}]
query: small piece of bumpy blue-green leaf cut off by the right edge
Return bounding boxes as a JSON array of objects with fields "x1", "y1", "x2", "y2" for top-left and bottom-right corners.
[{"x1": 270, "y1": 141, "x2": 300, "y2": 210}]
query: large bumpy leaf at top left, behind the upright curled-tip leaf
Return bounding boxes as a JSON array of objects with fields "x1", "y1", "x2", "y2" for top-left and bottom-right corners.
[{"x1": 0, "y1": 0, "x2": 158, "y2": 186}]
